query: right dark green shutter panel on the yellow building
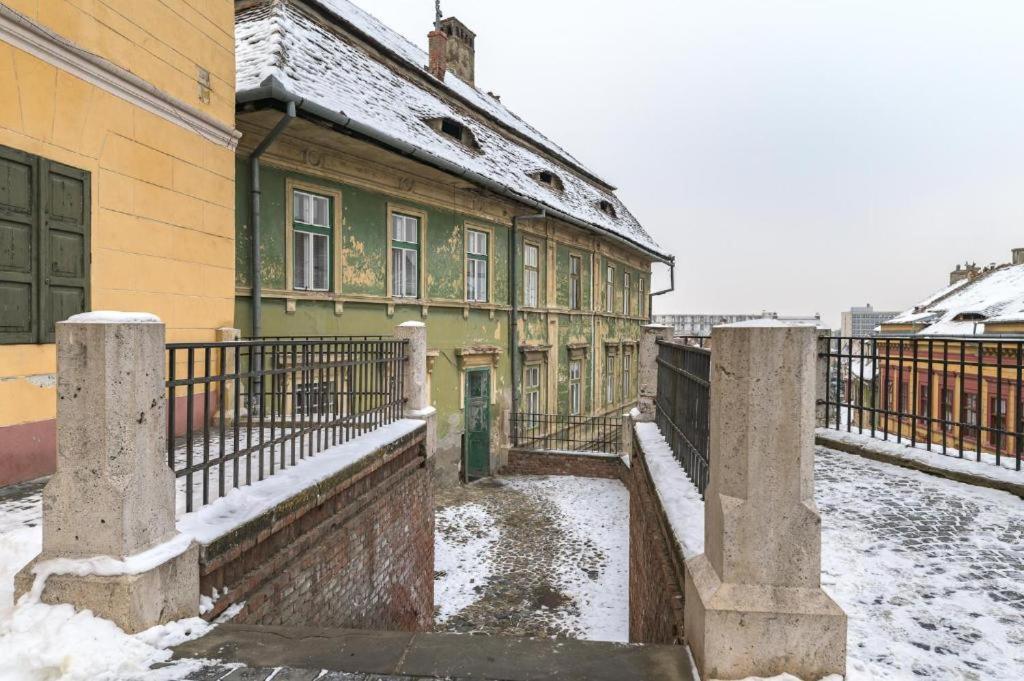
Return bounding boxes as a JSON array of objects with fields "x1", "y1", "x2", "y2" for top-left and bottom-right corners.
[{"x1": 39, "y1": 160, "x2": 91, "y2": 343}]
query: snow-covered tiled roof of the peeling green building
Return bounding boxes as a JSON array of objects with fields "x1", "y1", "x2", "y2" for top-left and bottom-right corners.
[{"x1": 234, "y1": 0, "x2": 672, "y2": 258}]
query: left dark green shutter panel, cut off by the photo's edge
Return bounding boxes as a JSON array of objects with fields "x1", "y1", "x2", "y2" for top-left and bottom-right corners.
[{"x1": 0, "y1": 146, "x2": 39, "y2": 343}]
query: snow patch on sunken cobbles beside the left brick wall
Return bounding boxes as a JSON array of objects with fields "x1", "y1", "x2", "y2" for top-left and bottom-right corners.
[{"x1": 434, "y1": 504, "x2": 500, "y2": 623}]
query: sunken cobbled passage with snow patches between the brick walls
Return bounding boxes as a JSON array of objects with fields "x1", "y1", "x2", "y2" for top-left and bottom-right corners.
[{"x1": 434, "y1": 476, "x2": 629, "y2": 641}]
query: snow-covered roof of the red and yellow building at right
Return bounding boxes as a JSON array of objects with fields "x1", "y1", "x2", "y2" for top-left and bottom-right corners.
[{"x1": 886, "y1": 265, "x2": 1024, "y2": 336}]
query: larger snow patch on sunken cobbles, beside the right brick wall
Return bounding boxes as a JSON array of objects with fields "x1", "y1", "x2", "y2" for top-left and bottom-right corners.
[{"x1": 508, "y1": 475, "x2": 630, "y2": 641}]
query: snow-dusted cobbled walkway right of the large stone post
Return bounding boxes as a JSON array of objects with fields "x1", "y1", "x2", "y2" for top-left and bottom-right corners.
[{"x1": 816, "y1": 448, "x2": 1024, "y2": 681}]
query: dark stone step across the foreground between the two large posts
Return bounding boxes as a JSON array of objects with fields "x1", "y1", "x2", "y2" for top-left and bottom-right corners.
[{"x1": 175, "y1": 625, "x2": 693, "y2": 681}]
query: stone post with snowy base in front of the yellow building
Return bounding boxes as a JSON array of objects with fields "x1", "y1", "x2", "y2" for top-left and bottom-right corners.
[{"x1": 15, "y1": 312, "x2": 199, "y2": 633}]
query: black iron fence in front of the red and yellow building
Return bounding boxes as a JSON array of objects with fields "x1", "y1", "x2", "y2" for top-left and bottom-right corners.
[{"x1": 820, "y1": 336, "x2": 1024, "y2": 470}]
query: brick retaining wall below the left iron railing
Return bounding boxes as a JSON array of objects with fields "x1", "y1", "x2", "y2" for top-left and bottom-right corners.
[{"x1": 201, "y1": 429, "x2": 434, "y2": 631}]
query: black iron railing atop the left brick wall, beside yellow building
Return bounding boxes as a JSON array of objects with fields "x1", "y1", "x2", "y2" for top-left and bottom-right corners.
[{"x1": 167, "y1": 337, "x2": 408, "y2": 512}]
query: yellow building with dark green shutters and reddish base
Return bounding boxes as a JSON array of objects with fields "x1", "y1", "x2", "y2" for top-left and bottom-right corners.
[{"x1": 0, "y1": 0, "x2": 238, "y2": 484}]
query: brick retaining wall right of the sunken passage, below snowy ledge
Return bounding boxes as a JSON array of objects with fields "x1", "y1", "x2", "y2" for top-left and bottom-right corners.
[{"x1": 629, "y1": 428, "x2": 684, "y2": 643}]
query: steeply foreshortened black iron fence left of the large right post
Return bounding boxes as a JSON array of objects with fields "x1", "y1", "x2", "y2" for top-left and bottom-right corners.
[{"x1": 654, "y1": 338, "x2": 711, "y2": 497}]
